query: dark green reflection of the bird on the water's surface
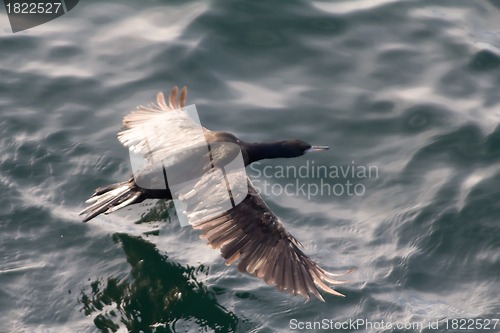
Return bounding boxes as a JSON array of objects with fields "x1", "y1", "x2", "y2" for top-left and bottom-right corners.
[{"x1": 78, "y1": 234, "x2": 238, "y2": 332}]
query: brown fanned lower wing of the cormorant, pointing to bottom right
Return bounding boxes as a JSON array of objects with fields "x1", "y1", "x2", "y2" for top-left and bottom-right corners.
[{"x1": 191, "y1": 179, "x2": 344, "y2": 301}]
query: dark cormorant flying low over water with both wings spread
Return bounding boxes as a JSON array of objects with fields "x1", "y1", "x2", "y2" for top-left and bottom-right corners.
[{"x1": 80, "y1": 87, "x2": 343, "y2": 300}]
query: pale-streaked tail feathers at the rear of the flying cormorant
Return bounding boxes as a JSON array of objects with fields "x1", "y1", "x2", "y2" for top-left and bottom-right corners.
[{"x1": 80, "y1": 178, "x2": 144, "y2": 222}]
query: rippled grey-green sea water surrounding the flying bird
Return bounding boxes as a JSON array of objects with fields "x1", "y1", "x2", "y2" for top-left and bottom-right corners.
[{"x1": 0, "y1": 0, "x2": 500, "y2": 332}]
